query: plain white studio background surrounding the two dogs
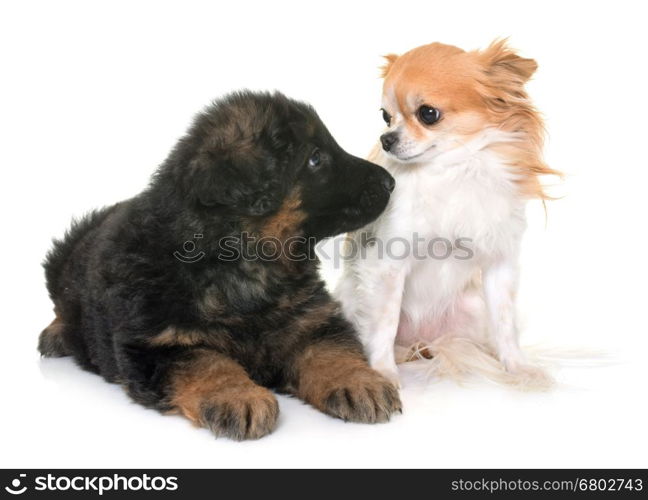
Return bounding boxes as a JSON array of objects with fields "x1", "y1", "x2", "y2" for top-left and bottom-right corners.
[{"x1": 0, "y1": 0, "x2": 648, "y2": 468}]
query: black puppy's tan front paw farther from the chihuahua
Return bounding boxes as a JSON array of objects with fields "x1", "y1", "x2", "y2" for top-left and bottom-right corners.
[{"x1": 199, "y1": 386, "x2": 279, "y2": 441}]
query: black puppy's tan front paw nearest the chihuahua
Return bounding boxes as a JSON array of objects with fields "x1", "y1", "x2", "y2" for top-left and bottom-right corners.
[{"x1": 322, "y1": 368, "x2": 402, "y2": 423}]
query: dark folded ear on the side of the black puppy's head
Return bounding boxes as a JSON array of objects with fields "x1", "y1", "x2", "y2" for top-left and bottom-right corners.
[{"x1": 185, "y1": 153, "x2": 278, "y2": 216}]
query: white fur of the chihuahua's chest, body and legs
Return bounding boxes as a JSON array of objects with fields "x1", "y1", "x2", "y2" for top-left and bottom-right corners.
[{"x1": 336, "y1": 129, "x2": 551, "y2": 388}]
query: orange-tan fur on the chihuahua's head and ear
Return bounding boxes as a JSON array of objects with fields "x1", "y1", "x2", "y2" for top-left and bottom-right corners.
[{"x1": 382, "y1": 40, "x2": 560, "y2": 199}]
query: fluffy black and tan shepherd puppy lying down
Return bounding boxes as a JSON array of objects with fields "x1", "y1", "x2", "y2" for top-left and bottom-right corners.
[{"x1": 39, "y1": 92, "x2": 401, "y2": 439}]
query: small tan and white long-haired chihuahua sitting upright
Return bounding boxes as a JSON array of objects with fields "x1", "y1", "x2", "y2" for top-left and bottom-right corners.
[{"x1": 336, "y1": 41, "x2": 557, "y2": 387}]
